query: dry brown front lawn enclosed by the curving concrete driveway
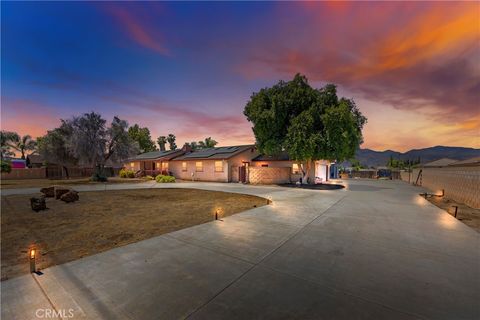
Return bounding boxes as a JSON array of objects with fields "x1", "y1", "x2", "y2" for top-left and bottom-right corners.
[{"x1": 1, "y1": 189, "x2": 267, "y2": 280}]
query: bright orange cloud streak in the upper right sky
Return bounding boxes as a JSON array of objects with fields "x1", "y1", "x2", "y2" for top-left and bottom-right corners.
[{"x1": 348, "y1": 3, "x2": 480, "y2": 78}]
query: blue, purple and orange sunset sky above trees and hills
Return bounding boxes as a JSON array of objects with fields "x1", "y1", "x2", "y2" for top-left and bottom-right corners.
[{"x1": 1, "y1": 2, "x2": 480, "y2": 151}]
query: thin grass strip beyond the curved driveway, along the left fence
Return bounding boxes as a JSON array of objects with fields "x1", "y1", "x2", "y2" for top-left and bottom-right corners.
[{"x1": 1, "y1": 177, "x2": 145, "y2": 189}]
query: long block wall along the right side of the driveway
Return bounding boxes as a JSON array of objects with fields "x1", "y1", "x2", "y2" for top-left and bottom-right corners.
[{"x1": 401, "y1": 166, "x2": 480, "y2": 209}]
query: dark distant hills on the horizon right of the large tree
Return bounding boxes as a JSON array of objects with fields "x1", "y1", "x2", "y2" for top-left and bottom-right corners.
[{"x1": 348, "y1": 146, "x2": 480, "y2": 167}]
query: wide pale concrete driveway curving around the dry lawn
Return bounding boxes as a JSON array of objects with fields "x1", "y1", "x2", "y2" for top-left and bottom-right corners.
[{"x1": 1, "y1": 180, "x2": 480, "y2": 320}]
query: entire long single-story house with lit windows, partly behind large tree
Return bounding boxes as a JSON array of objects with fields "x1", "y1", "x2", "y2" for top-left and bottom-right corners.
[{"x1": 125, "y1": 144, "x2": 332, "y2": 184}]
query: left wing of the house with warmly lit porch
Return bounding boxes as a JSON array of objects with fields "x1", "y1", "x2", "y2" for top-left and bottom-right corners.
[{"x1": 124, "y1": 148, "x2": 188, "y2": 176}]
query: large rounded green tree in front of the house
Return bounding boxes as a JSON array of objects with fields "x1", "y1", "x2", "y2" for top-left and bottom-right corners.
[{"x1": 244, "y1": 74, "x2": 367, "y2": 181}]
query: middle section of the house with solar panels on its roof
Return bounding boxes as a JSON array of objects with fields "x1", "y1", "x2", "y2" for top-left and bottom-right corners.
[{"x1": 170, "y1": 145, "x2": 258, "y2": 182}]
